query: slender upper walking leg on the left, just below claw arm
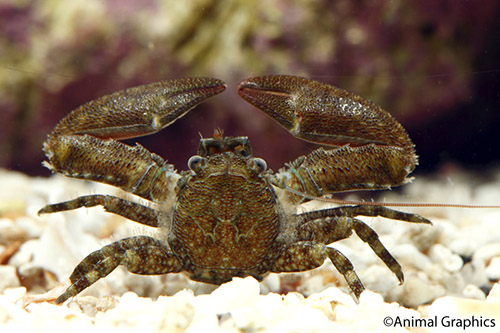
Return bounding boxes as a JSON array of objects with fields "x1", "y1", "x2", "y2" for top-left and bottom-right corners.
[{"x1": 38, "y1": 194, "x2": 159, "y2": 227}]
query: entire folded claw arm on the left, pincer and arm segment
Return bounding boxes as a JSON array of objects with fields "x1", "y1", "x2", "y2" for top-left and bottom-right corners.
[{"x1": 44, "y1": 78, "x2": 226, "y2": 201}]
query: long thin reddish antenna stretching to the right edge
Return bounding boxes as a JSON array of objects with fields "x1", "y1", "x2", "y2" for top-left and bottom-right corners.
[{"x1": 285, "y1": 186, "x2": 500, "y2": 209}]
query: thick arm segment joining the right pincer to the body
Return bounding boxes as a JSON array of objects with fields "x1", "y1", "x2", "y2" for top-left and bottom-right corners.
[{"x1": 275, "y1": 143, "x2": 415, "y2": 202}]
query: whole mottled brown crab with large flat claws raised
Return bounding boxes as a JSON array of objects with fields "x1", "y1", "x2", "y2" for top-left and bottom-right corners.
[{"x1": 39, "y1": 75, "x2": 430, "y2": 303}]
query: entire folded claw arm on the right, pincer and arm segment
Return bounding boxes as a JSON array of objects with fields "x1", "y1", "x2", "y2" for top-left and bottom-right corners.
[{"x1": 238, "y1": 75, "x2": 417, "y2": 200}]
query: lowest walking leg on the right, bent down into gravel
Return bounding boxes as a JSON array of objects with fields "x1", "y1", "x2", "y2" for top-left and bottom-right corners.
[{"x1": 271, "y1": 241, "x2": 365, "y2": 299}]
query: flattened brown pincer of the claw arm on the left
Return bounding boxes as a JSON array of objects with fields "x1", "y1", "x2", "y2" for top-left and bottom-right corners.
[{"x1": 49, "y1": 77, "x2": 226, "y2": 140}]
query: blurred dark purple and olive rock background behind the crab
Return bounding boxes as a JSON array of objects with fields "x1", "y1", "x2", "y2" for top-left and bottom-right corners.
[{"x1": 0, "y1": 0, "x2": 500, "y2": 179}]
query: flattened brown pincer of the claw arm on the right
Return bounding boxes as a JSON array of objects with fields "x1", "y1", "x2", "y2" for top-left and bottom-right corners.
[{"x1": 238, "y1": 75, "x2": 414, "y2": 153}]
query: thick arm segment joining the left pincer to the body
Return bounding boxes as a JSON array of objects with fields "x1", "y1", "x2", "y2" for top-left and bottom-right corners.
[{"x1": 44, "y1": 135, "x2": 175, "y2": 201}]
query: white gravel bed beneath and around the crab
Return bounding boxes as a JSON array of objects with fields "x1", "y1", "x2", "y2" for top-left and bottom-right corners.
[{"x1": 0, "y1": 170, "x2": 500, "y2": 332}]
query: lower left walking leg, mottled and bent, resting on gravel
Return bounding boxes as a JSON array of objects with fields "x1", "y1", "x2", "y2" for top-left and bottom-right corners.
[{"x1": 56, "y1": 236, "x2": 182, "y2": 304}]
